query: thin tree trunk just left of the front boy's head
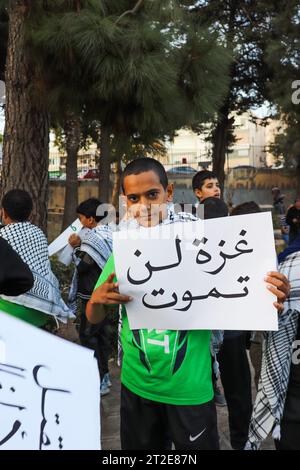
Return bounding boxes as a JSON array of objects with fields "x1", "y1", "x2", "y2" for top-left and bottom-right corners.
[{"x1": 99, "y1": 125, "x2": 110, "y2": 203}]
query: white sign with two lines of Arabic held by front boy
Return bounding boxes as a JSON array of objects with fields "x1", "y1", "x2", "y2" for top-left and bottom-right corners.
[{"x1": 114, "y1": 213, "x2": 278, "y2": 330}]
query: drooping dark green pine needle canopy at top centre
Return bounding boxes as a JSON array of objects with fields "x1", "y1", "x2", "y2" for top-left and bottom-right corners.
[{"x1": 28, "y1": 0, "x2": 228, "y2": 138}]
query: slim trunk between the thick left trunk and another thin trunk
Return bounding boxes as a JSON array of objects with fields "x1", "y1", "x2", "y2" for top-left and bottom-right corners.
[{"x1": 62, "y1": 115, "x2": 81, "y2": 230}]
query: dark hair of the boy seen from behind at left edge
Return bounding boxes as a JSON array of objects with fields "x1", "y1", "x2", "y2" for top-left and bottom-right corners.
[{"x1": 1, "y1": 189, "x2": 33, "y2": 222}]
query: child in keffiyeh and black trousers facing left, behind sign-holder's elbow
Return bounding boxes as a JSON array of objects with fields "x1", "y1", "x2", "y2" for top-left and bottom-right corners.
[{"x1": 69, "y1": 198, "x2": 112, "y2": 396}]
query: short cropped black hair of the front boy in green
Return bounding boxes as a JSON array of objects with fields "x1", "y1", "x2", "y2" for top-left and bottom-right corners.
[{"x1": 122, "y1": 157, "x2": 169, "y2": 192}]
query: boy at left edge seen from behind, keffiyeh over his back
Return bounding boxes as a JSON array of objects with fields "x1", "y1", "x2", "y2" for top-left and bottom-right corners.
[{"x1": 0, "y1": 189, "x2": 74, "y2": 327}]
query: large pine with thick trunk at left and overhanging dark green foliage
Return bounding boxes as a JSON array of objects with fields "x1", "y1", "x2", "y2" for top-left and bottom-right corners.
[{"x1": 3, "y1": 0, "x2": 228, "y2": 228}]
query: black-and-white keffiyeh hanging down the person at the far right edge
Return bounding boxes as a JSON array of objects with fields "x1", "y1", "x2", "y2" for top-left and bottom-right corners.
[{"x1": 245, "y1": 251, "x2": 300, "y2": 450}]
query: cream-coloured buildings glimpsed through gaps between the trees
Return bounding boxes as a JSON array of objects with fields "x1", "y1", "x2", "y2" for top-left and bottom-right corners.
[{"x1": 49, "y1": 112, "x2": 280, "y2": 179}]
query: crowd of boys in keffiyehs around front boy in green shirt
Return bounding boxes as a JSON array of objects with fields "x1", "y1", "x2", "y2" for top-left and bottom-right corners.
[{"x1": 0, "y1": 158, "x2": 300, "y2": 451}]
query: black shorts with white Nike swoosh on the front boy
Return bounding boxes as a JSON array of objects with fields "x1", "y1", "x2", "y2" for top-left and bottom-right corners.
[{"x1": 121, "y1": 385, "x2": 219, "y2": 451}]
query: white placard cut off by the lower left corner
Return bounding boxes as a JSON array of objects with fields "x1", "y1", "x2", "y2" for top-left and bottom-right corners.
[{"x1": 0, "y1": 312, "x2": 100, "y2": 450}]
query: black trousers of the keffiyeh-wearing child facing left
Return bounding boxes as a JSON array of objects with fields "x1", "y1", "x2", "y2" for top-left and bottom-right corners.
[{"x1": 78, "y1": 301, "x2": 111, "y2": 380}]
